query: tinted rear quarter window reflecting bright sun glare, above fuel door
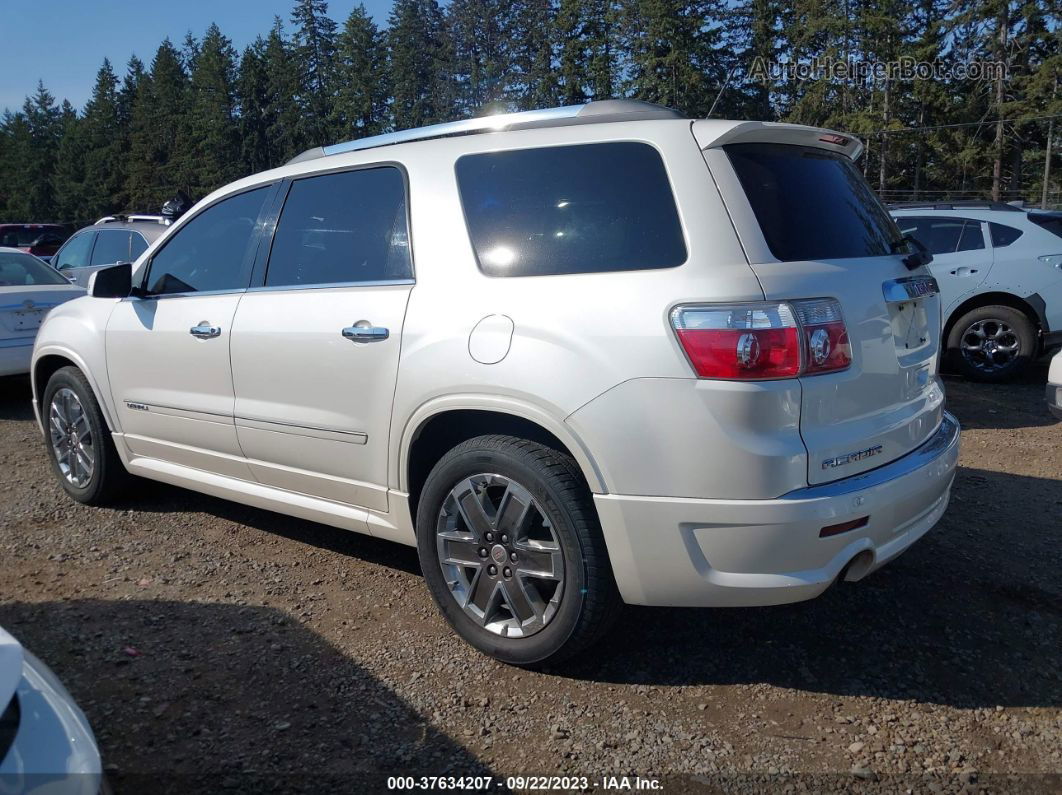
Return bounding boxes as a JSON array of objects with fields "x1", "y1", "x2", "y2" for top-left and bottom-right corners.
[{"x1": 457, "y1": 142, "x2": 686, "y2": 276}]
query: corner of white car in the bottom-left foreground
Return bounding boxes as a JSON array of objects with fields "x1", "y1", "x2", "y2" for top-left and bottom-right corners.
[{"x1": 0, "y1": 628, "x2": 103, "y2": 795}]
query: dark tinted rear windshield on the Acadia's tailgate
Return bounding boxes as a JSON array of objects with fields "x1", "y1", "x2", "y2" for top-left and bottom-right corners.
[{"x1": 723, "y1": 143, "x2": 904, "y2": 262}]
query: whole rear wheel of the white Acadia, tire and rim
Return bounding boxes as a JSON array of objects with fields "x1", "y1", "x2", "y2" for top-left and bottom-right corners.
[{"x1": 416, "y1": 435, "x2": 620, "y2": 666}]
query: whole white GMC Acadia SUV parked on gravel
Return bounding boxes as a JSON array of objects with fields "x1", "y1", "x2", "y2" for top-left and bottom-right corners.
[{"x1": 32, "y1": 101, "x2": 959, "y2": 664}]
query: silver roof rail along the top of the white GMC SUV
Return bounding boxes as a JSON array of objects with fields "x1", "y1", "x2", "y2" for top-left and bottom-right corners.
[{"x1": 286, "y1": 100, "x2": 685, "y2": 166}]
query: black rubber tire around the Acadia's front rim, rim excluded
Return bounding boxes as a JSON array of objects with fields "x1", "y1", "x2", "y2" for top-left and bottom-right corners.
[{"x1": 40, "y1": 366, "x2": 129, "y2": 505}]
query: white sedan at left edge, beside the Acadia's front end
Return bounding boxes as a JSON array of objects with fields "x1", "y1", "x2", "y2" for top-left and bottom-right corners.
[{"x1": 0, "y1": 247, "x2": 85, "y2": 376}]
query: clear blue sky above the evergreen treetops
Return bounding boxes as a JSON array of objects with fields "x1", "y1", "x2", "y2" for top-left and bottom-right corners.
[{"x1": 0, "y1": 0, "x2": 391, "y2": 109}]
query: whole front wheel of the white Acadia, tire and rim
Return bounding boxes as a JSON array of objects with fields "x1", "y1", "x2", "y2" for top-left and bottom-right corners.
[{"x1": 40, "y1": 366, "x2": 131, "y2": 505}]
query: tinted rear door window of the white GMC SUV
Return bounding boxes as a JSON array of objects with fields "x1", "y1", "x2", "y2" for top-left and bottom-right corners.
[{"x1": 266, "y1": 166, "x2": 413, "y2": 287}]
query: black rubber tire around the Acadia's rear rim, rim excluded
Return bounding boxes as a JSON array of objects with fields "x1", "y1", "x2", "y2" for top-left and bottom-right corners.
[{"x1": 416, "y1": 437, "x2": 607, "y2": 666}]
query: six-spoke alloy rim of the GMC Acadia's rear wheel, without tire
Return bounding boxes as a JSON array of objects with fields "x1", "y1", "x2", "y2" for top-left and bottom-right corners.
[{"x1": 435, "y1": 473, "x2": 564, "y2": 638}]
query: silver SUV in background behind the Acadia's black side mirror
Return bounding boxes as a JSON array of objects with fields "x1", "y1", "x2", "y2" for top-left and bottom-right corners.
[{"x1": 51, "y1": 215, "x2": 169, "y2": 287}]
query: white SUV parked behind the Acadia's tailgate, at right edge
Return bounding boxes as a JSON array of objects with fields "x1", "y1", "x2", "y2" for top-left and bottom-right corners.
[{"x1": 891, "y1": 202, "x2": 1062, "y2": 381}]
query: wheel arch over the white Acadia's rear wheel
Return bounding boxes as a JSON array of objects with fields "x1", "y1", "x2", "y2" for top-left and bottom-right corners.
[{"x1": 396, "y1": 396, "x2": 606, "y2": 526}]
